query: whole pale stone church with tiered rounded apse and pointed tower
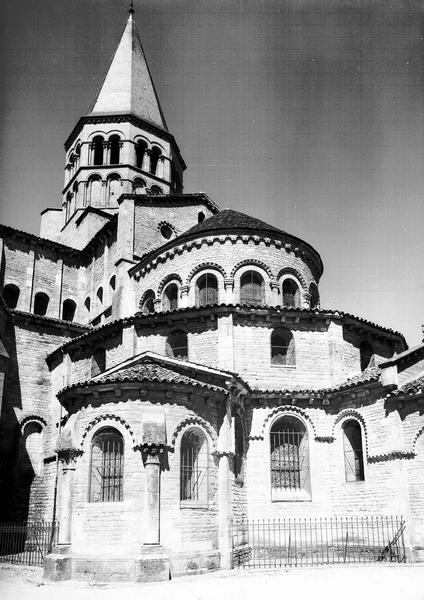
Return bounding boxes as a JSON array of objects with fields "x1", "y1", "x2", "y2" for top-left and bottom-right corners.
[{"x1": 0, "y1": 9, "x2": 424, "y2": 580}]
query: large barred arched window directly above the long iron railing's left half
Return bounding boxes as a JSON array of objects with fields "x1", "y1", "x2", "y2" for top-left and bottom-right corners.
[{"x1": 270, "y1": 416, "x2": 310, "y2": 491}]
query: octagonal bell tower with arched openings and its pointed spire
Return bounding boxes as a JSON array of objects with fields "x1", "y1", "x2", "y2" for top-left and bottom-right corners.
[{"x1": 61, "y1": 7, "x2": 185, "y2": 230}]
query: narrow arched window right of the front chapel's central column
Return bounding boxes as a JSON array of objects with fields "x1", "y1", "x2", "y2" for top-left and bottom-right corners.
[{"x1": 180, "y1": 428, "x2": 208, "y2": 506}]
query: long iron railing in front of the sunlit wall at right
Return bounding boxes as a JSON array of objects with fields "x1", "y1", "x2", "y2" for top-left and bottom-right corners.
[{"x1": 232, "y1": 516, "x2": 405, "y2": 569}]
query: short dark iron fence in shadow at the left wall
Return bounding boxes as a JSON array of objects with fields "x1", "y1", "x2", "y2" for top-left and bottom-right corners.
[{"x1": 0, "y1": 521, "x2": 59, "y2": 566}]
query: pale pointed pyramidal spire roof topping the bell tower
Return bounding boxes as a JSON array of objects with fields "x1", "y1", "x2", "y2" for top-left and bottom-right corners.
[{"x1": 90, "y1": 7, "x2": 167, "y2": 130}]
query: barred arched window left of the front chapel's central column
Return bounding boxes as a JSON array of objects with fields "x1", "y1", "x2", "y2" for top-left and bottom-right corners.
[{"x1": 89, "y1": 427, "x2": 124, "y2": 502}]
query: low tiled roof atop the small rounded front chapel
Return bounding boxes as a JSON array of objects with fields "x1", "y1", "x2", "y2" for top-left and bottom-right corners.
[{"x1": 59, "y1": 362, "x2": 227, "y2": 395}]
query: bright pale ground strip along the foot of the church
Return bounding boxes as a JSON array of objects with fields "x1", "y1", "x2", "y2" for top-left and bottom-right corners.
[{"x1": 0, "y1": 564, "x2": 424, "y2": 600}]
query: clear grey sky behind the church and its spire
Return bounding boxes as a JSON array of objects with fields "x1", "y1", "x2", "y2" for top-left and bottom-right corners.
[{"x1": 0, "y1": 0, "x2": 424, "y2": 346}]
